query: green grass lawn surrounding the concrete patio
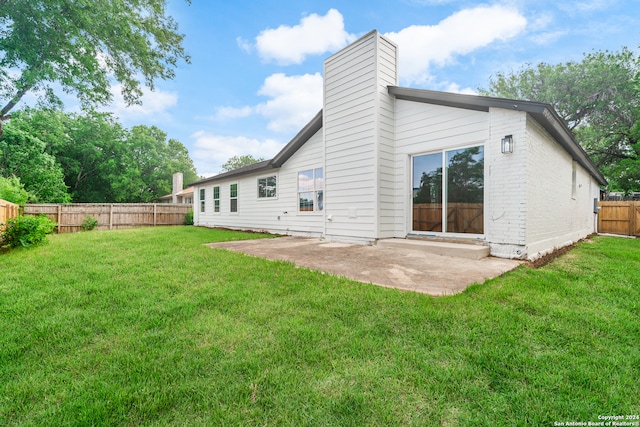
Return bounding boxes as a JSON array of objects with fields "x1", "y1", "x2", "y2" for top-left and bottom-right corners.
[{"x1": 0, "y1": 227, "x2": 640, "y2": 426}]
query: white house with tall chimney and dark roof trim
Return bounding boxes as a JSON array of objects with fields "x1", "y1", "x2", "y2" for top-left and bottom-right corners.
[{"x1": 193, "y1": 31, "x2": 606, "y2": 259}]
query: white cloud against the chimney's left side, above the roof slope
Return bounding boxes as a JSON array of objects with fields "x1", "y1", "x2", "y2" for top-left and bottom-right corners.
[{"x1": 256, "y1": 73, "x2": 323, "y2": 132}]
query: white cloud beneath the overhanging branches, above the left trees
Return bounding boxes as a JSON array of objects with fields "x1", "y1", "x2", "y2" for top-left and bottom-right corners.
[{"x1": 105, "y1": 84, "x2": 178, "y2": 121}]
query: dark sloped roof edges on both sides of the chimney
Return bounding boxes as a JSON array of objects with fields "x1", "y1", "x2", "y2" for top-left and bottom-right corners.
[{"x1": 189, "y1": 86, "x2": 607, "y2": 186}]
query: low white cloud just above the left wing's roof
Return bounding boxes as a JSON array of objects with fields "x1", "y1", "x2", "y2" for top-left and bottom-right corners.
[{"x1": 190, "y1": 131, "x2": 283, "y2": 176}]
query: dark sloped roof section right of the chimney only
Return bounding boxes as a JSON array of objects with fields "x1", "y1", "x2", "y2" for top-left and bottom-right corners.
[{"x1": 388, "y1": 86, "x2": 607, "y2": 185}]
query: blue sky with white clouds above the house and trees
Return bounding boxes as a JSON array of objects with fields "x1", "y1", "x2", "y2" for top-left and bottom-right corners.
[{"x1": 95, "y1": 0, "x2": 640, "y2": 176}]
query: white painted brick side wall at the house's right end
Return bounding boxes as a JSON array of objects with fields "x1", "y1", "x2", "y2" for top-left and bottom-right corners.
[{"x1": 526, "y1": 115, "x2": 599, "y2": 258}]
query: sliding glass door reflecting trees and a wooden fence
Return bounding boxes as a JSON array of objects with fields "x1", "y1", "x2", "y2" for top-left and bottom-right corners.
[{"x1": 412, "y1": 145, "x2": 484, "y2": 234}]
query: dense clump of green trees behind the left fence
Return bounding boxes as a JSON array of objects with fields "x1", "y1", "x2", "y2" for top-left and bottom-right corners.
[{"x1": 5, "y1": 109, "x2": 198, "y2": 203}]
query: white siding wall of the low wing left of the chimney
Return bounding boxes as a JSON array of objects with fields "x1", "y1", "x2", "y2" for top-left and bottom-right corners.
[{"x1": 194, "y1": 130, "x2": 323, "y2": 236}]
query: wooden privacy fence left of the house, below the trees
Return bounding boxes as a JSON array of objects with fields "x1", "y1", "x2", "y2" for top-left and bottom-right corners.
[{"x1": 24, "y1": 203, "x2": 193, "y2": 233}]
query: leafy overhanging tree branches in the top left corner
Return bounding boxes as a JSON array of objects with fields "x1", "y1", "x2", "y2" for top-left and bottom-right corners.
[{"x1": 0, "y1": 0, "x2": 189, "y2": 131}]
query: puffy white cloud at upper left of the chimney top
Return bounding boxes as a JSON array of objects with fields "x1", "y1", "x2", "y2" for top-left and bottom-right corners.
[{"x1": 254, "y1": 9, "x2": 356, "y2": 65}]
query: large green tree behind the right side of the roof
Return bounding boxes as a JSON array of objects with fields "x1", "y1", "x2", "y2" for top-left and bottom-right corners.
[{"x1": 481, "y1": 48, "x2": 640, "y2": 190}]
